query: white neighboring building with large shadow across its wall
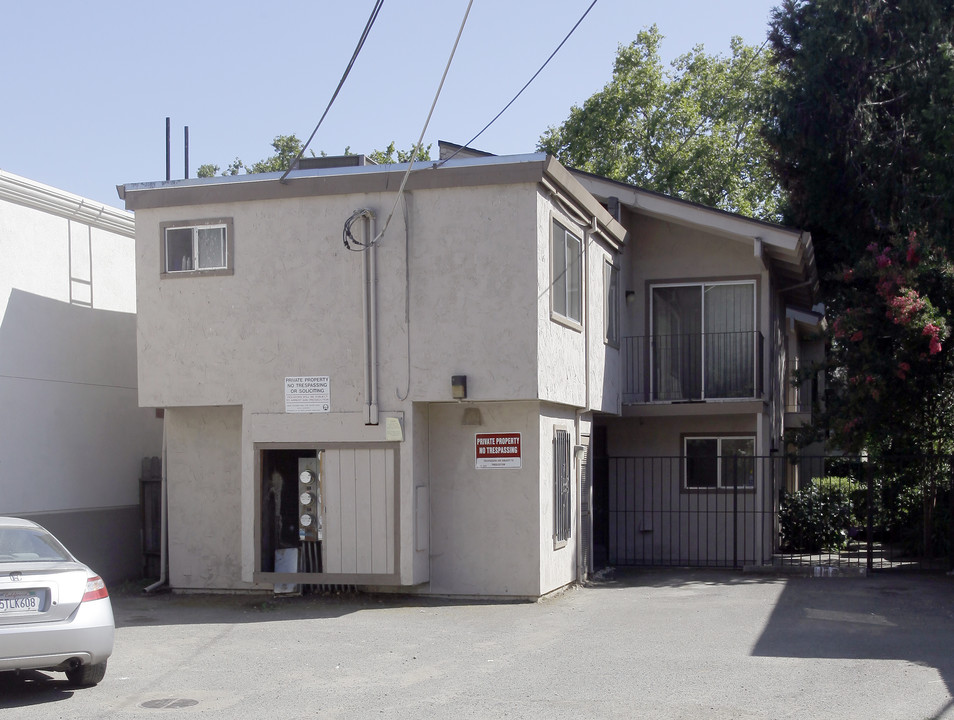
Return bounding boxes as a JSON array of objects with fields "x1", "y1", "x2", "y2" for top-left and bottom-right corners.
[{"x1": 0, "y1": 170, "x2": 162, "y2": 582}]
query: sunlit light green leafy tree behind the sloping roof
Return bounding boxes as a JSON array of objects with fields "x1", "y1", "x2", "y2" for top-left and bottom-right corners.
[{"x1": 538, "y1": 25, "x2": 780, "y2": 220}]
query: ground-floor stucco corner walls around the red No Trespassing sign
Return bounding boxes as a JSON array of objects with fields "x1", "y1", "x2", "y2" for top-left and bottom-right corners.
[{"x1": 427, "y1": 402, "x2": 579, "y2": 597}]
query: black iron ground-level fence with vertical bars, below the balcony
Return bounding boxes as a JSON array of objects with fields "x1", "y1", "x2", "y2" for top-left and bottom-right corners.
[{"x1": 597, "y1": 456, "x2": 954, "y2": 570}]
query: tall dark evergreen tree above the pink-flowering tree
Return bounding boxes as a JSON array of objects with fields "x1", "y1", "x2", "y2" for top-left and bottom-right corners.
[{"x1": 766, "y1": 0, "x2": 954, "y2": 276}]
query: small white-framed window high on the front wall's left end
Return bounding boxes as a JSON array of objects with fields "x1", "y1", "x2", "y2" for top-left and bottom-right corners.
[{"x1": 159, "y1": 218, "x2": 233, "y2": 277}]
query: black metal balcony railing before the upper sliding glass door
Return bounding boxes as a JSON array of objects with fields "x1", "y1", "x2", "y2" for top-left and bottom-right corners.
[{"x1": 621, "y1": 331, "x2": 763, "y2": 405}]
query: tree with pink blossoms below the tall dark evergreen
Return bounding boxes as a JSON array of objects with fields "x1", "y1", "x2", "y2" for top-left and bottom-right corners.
[{"x1": 808, "y1": 232, "x2": 954, "y2": 454}]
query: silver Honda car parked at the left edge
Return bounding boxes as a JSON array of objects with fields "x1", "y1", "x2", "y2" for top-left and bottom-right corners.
[{"x1": 0, "y1": 517, "x2": 115, "y2": 686}]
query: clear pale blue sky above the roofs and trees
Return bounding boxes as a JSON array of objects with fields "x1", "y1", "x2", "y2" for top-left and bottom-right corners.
[{"x1": 0, "y1": 0, "x2": 778, "y2": 207}]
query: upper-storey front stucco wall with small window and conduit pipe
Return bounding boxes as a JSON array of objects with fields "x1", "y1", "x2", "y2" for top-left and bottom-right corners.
[{"x1": 130, "y1": 185, "x2": 545, "y2": 412}]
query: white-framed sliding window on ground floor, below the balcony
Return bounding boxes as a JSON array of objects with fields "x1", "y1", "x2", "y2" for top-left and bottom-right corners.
[{"x1": 683, "y1": 436, "x2": 755, "y2": 490}]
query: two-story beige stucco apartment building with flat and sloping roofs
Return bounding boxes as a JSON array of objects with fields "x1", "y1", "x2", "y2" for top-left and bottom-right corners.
[{"x1": 119, "y1": 143, "x2": 816, "y2": 598}]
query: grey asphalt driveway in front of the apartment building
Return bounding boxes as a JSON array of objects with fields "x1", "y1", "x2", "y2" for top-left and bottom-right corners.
[{"x1": 0, "y1": 571, "x2": 954, "y2": 720}]
